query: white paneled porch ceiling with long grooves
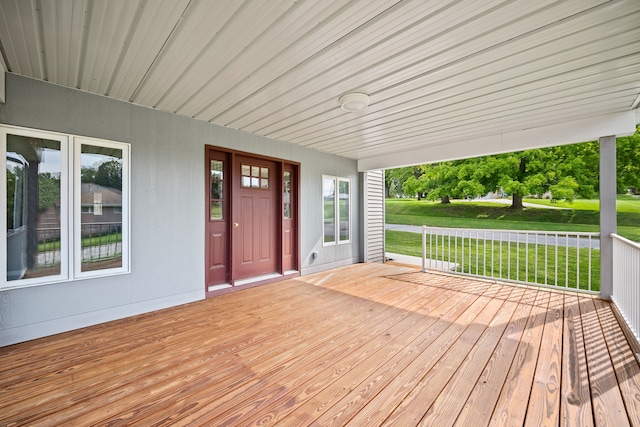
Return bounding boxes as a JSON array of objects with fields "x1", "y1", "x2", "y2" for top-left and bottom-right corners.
[{"x1": 0, "y1": 0, "x2": 640, "y2": 171}]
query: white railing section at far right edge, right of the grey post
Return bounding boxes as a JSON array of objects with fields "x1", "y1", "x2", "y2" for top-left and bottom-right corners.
[{"x1": 611, "y1": 234, "x2": 640, "y2": 348}]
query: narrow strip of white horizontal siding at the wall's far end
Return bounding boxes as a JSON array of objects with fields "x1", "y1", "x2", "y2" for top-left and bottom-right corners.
[{"x1": 364, "y1": 170, "x2": 384, "y2": 262}]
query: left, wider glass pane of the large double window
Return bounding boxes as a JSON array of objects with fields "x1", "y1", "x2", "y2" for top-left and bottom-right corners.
[{"x1": 5, "y1": 135, "x2": 62, "y2": 280}]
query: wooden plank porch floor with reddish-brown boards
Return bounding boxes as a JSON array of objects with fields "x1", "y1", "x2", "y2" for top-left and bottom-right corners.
[{"x1": 0, "y1": 264, "x2": 640, "y2": 427}]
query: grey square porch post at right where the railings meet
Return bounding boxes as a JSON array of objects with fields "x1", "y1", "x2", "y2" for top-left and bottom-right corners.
[{"x1": 600, "y1": 136, "x2": 617, "y2": 299}]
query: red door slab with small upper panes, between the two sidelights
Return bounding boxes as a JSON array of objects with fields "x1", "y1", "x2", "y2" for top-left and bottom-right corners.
[{"x1": 232, "y1": 155, "x2": 280, "y2": 280}]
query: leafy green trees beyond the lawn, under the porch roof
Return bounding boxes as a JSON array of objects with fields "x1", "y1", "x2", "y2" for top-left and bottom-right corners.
[{"x1": 385, "y1": 126, "x2": 640, "y2": 209}]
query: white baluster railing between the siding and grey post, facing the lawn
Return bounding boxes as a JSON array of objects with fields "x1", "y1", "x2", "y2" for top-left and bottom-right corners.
[{"x1": 422, "y1": 226, "x2": 600, "y2": 293}]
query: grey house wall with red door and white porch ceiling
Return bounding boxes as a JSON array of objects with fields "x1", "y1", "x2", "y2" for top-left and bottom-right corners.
[{"x1": 0, "y1": 0, "x2": 640, "y2": 346}]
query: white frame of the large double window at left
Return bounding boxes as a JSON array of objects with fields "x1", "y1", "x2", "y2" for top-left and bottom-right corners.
[{"x1": 0, "y1": 124, "x2": 131, "y2": 291}]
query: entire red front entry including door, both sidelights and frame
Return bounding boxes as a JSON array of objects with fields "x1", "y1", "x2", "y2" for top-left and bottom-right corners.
[{"x1": 205, "y1": 147, "x2": 300, "y2": 296}]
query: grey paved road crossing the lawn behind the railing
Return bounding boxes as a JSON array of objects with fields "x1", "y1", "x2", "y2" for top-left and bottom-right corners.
[{"x1": 384, "y1": 224, "x2": 600, "y2": 249}]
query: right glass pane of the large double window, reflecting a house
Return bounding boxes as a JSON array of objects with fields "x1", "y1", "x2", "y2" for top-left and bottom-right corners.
[{"x1": 80, "y1": 144, "x2": 123, "y2": 271}]
